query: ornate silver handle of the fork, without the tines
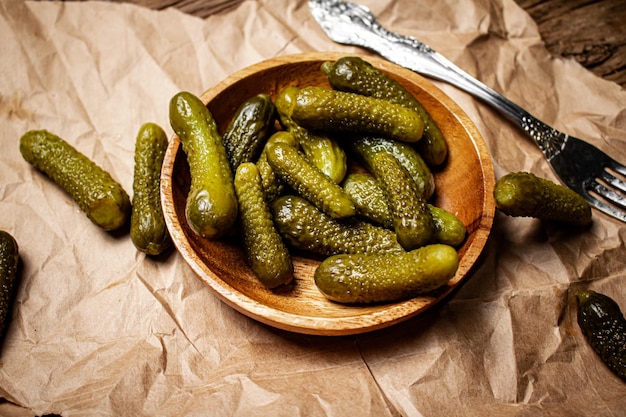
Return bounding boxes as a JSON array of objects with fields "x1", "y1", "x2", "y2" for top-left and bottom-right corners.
[{"x1": 325, "y1": 1, "x2": 568, "y2": 160}]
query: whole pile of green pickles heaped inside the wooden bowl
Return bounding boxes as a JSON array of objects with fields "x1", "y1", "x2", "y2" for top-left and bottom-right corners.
[{"x1": 169, "y1": 57, "x2": 466, "y2": 303}]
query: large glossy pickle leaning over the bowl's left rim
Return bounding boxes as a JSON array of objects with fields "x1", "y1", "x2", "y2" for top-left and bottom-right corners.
[{"x1": 169, "y1": 91, "x2": 238, "y2": 239}]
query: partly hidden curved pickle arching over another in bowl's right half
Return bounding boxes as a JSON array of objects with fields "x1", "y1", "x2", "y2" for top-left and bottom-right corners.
[{"x1": 347, "y1": 136, "x2": 435, "y2": 200}]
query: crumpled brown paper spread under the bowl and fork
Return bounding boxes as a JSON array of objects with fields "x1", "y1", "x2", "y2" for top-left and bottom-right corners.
[{"x1": 0, "y1": 0, "x2": 626, "y2": 417}]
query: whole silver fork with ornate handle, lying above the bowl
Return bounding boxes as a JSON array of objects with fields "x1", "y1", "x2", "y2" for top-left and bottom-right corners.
[{"x1": 309, "y1": 0, "x2": 626, "y2": 222}]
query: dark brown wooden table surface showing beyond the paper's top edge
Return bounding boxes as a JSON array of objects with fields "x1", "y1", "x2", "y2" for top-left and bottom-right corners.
[{"x1": 90, "y1": 0, "x2": 626, "y2": 88}]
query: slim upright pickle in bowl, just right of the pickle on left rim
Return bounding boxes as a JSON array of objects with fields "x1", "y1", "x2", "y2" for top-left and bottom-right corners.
[{"x1": 235, "y1": 162, "x2": 293, "y2": 288}]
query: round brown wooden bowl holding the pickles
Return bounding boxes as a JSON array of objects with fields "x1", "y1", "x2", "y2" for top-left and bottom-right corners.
[{"x1": 161, "y1": 53, "x2": 495, "y2": 335}]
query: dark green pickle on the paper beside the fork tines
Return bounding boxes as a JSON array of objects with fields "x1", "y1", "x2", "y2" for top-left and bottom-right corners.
[{"x1": 494, "y1": 172, "x2": 592, "y2": 226}]
